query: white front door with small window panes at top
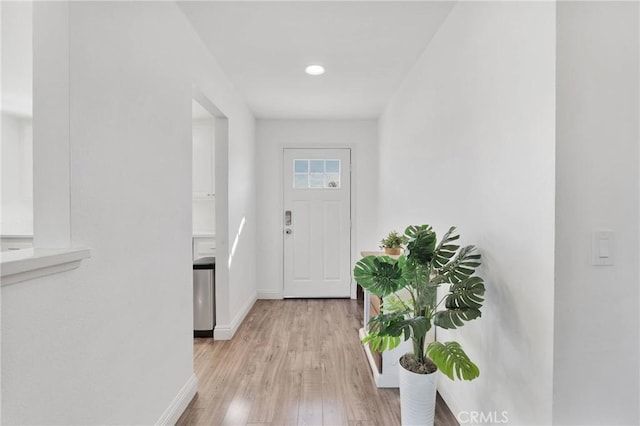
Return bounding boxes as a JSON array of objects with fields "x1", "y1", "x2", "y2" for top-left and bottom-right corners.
[{"x1": 282, "y1": 149, "x2": 351, "y2": 297}]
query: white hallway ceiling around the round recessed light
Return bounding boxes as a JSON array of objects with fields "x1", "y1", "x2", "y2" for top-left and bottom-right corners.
[{"x1": 178, "y1": 1, "x2": 454, "y2": 118}]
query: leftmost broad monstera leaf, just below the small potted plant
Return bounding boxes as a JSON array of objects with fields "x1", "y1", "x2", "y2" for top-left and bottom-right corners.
[{"x1": 353, "y1": 256, "x2": 406, "y2": 297}]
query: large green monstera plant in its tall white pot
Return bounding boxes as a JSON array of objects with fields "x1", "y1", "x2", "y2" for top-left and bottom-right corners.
[{"x1": 354, "y1": 225, "x2": 485, "y2": 425}]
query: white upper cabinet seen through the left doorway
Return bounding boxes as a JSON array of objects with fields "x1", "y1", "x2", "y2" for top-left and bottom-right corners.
[{"x1": 192, "y1": 119, "x2": 216, "y2": 199}]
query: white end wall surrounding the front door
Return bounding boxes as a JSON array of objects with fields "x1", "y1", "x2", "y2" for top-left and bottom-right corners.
[{"x1": 256, "y1": 120, "x2": 381, "y2": 298}]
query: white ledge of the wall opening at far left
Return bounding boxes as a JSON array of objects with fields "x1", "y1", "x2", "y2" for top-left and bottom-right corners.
[{"x1": 0, "y1": 248, "x2": 91, "y2": 287}]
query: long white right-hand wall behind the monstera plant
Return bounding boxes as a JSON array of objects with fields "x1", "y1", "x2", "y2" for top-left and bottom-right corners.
[{"x1": 378, "y1": 2, "x2": 555, "y2": 424}]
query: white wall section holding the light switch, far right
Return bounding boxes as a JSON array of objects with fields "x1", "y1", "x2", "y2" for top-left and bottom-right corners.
[{"x1": 553, "y1": 2, "x2": 640, "y2": 425}]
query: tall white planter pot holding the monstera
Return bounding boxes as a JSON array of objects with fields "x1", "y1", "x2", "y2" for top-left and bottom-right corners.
[{"x1": 398, "y1": 365, "x2": 438, "y2": 426}]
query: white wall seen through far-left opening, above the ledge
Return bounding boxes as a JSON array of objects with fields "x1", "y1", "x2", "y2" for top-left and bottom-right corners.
[{"x1": 0, "y1": 112, "x2": 33, "y2": 235}]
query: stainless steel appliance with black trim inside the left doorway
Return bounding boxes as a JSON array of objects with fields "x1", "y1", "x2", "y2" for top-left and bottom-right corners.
[{"x1": 193, "y1": 257, "x2": 216, "y2": 337}]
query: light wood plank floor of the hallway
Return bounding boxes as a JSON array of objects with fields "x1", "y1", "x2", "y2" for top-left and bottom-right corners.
[{"x1": 178, "y1": 299, "x2": 457, "y2": 426}]
